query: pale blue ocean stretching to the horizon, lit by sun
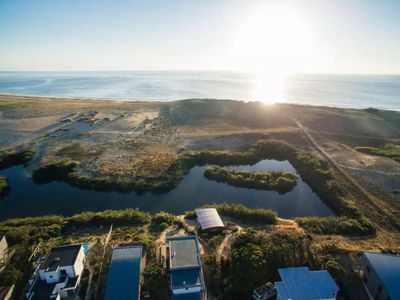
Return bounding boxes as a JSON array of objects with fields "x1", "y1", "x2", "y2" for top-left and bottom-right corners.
[{"x1": 0, "y1": 71, "x2": 400, "y2": 111}]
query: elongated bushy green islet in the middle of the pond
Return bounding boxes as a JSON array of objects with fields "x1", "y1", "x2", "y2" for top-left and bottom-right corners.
[{"x1": 204, "y1": 167, "x2": 297, "y2": 194}]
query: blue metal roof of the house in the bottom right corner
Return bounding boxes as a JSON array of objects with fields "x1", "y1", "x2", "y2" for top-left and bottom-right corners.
[{"x1": 364, "y1": 252, "x2": 400, "y2": 299}]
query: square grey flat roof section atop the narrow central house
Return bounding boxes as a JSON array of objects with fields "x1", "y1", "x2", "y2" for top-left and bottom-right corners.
[{"x1": 167, "y1": 236, "x2": 200, "y2": 269}]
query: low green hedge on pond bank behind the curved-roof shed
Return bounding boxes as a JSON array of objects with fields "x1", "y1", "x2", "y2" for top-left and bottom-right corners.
[{"x1": 185, "y1": 203, "x2": 278, "y2": 225}]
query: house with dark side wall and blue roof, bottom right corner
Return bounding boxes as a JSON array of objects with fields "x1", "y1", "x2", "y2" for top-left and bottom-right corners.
[{"x1": 361, "y1": 252, "x2": 400, "y2": 300}]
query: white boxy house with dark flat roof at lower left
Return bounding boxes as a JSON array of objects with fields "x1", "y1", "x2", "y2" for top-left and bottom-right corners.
[{"x1": 26, "y1": 244, "x2": 85, "y2": 300}]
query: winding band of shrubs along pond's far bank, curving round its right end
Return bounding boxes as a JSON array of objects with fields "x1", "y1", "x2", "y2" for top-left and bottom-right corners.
[{"x1": 29, "y1": 139, "x2": 375, "y2": 235}]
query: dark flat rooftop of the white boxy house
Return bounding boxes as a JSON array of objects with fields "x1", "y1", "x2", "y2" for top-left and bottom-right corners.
[{"x1": 40, "y1": 244, "x2": 82, "y2": 271}]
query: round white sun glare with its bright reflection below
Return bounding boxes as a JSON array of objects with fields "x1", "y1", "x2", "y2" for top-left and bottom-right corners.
[{"x1": 234, "y1": 6, "x2": 315, "y2": 103}]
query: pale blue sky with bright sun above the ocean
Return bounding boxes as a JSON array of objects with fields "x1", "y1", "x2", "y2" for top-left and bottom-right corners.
[{"x1": 0, "y1": 0, "x2": 400, "y2": 74}]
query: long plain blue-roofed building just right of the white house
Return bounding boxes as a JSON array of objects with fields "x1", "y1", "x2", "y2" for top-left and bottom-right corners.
[{"x1": 104, "y1": 245, "x2": 143, "y2": 300}]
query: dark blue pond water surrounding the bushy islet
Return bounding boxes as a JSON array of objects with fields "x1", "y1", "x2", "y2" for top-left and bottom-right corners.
[{"x1": 0, "y1": 160, "x2": 333, "y2": 219}]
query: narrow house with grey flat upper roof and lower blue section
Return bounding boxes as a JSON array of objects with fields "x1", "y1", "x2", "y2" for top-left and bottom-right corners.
[{"x1": 167, "y1": 236, "x2": 207, "y2": 300}]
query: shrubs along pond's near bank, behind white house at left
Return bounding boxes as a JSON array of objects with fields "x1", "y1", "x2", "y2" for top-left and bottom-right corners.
[{"x1": 0, "y1": 209, "x2": 156, "y2": 292}]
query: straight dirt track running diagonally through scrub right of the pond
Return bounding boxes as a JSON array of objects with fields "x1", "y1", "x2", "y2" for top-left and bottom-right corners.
[{"x1": 293, "y1": 119, "x2": 396, "y2": 229}]
